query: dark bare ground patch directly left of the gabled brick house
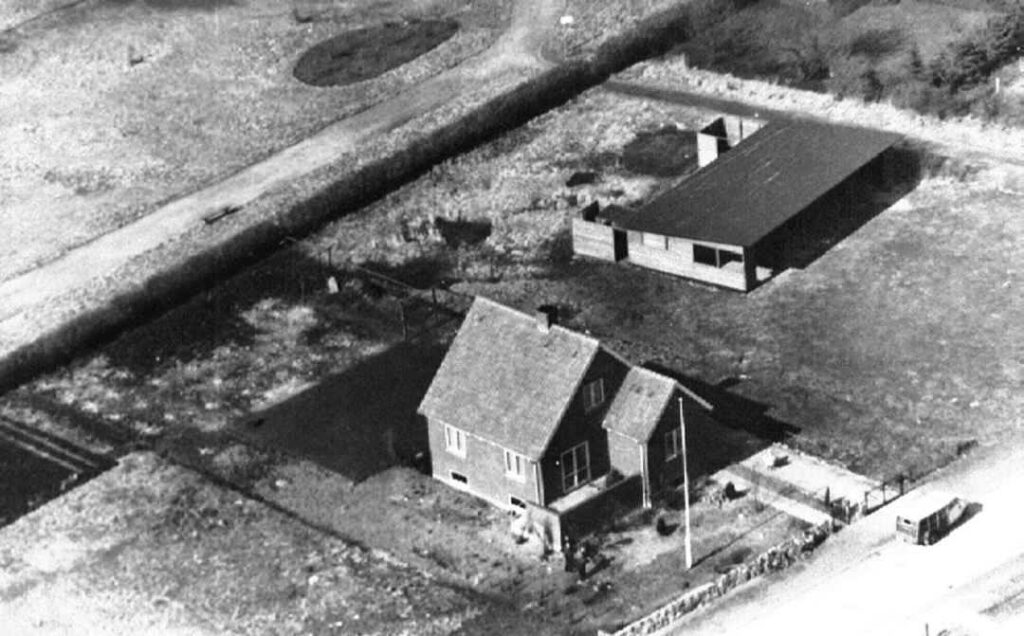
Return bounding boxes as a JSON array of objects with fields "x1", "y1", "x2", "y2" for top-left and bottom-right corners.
[{"x1": 232, "y1": 342, "x2": 443, "y2": 481}]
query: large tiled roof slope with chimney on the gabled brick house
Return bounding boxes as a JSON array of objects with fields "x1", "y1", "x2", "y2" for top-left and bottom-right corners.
[{"x1": 420, "y1": 296, "x2": 601, "y2": 460}]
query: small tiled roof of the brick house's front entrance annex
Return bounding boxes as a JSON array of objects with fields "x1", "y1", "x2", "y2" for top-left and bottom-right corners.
[{"x1": 604, "y1": 367, "x2": 712, "y2": 442}]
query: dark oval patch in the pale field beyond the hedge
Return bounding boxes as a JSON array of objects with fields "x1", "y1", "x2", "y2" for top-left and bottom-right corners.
[{"x1": 294, "y1": 19, "x2": 459, "y2": 86}]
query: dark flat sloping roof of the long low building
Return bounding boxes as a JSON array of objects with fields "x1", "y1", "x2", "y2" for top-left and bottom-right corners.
[{"x1": 605, "y1": 120, "x2": 900, "y2": 247}]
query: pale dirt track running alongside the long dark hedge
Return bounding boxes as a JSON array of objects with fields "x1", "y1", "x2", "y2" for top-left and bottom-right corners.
[{"x1": 0, "y1": 0, "x2": 563, "y2": 348}]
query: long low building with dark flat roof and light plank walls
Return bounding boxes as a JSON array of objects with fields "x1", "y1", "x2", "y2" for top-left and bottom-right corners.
[{"x1": 572, "y1": 119, "x2": 900, "y2": 291}]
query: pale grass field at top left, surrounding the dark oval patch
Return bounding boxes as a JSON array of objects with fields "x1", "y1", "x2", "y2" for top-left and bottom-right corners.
[{"x1": 0, "y1": 0, "x2": 508, "y2": 280}]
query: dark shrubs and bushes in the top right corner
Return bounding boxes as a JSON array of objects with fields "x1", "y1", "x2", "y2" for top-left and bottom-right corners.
[{"x1": 678, "y1": 0, "x2": 1024, "y2": 122}]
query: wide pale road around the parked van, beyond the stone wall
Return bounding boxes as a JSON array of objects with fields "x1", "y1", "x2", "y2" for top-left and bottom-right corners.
[{"x1": 666, "y1": 436, "x2": 1024, "y2": 636}]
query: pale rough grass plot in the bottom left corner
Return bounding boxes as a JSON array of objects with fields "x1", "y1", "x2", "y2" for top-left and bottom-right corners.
[{"x1": 0, "y1": 453, "x2": 484, "y2": 634}]
